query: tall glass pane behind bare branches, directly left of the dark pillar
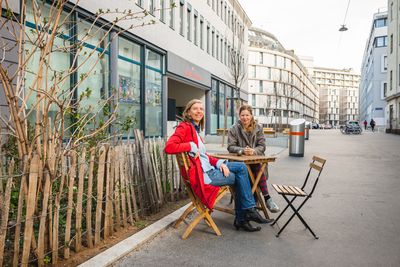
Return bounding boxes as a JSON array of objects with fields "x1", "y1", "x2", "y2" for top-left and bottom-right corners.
[{"x1": 77, "y1": 21, "x2": 109, "y2": 131}]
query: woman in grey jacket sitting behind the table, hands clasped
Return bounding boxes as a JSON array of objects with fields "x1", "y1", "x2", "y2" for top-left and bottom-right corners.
[{"x1": 228, "y1": 105, "x2": 279, "y2": 213}]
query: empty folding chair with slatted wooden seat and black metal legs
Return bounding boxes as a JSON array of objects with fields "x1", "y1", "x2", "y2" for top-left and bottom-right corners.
[{"x1": 271, "y1": 156, "x2": 326, "y2": 239}]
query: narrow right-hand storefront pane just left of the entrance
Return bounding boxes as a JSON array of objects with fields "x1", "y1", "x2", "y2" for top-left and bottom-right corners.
[{"x1": 145, "y1": 49, "x2": 162, "y2": 136}]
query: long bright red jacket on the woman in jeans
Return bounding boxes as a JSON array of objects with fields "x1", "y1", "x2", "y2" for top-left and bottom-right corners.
[{"x1": 164, "y1": 122, "x2": 219, "y2": 209}]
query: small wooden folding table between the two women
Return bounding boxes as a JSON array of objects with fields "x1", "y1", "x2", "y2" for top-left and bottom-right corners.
[{"x1": 211, "y1": 153, "x2": 276, "y2": 219}]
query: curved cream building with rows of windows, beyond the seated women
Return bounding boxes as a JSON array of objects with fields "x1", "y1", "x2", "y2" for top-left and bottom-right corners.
[{"x1": 248, "y1": 28, "x2": 318, "y2": 126}]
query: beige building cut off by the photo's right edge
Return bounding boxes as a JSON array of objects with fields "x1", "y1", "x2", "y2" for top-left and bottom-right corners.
[{"x1": 385, "y1": 0, "x2": 400, "y2": 134}]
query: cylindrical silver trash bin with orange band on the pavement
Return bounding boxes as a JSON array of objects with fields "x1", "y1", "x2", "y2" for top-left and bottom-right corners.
[{"x1": 289, "y1": 119, "x2": 306, "y2": 157}]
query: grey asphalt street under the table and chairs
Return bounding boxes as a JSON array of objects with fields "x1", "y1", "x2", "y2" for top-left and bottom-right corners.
[{"x1": 115, "y1": 130, "x2": 400, "y2": 266}]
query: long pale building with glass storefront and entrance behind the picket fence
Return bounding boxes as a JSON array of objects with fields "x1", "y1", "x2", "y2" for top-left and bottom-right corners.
[{"x1": 2, "y1": 0, "x2": 251, "y2": 137}]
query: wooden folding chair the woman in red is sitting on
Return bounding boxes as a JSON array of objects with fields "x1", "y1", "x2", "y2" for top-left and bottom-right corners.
[{"x1": 173, "y1": 153, "x2": 234, "y2": 239}]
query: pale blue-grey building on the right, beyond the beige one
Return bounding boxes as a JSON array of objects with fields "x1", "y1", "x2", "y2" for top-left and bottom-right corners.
[{"x1": 359, "y1": 12, "x2": 388, "y2": 127}]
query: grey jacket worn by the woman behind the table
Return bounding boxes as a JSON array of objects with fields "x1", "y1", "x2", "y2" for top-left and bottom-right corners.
[{"x1": 228, "y1": 121, "x2": 266, "y2": 155}]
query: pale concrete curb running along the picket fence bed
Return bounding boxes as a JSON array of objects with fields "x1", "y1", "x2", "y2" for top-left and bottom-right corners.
[{"x1": 78, "y1": 203, "x2": 190, "y2": 267}]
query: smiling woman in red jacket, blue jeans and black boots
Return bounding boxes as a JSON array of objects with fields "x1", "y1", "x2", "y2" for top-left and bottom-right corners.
[{"x1": 165, "y1": 99, "x2": 272, "y2": 232}]
